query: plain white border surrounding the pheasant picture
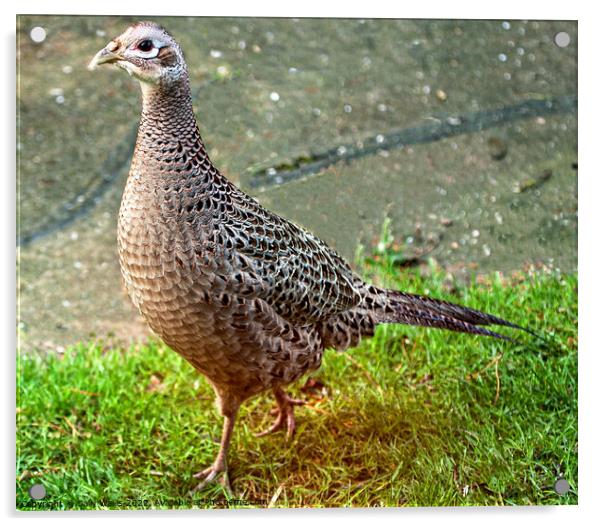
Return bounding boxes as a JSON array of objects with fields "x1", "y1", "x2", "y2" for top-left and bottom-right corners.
[{"x1": 0, "y1": 0, "x2": 602, "y2": 526}]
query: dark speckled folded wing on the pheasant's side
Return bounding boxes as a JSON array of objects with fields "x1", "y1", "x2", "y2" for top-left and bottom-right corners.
[{"x1": 198, "y1": 174, "x2": 361, "y2": 326}]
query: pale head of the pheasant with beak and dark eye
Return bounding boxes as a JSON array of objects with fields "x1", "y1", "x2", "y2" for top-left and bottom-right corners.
[{"x1": 88, "y1": 22, "x2": 188, "y2": 88}]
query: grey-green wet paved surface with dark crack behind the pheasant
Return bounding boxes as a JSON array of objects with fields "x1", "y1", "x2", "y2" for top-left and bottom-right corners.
[{"x1": 17, "y1": 16, "x2": 577, "y2": 349}]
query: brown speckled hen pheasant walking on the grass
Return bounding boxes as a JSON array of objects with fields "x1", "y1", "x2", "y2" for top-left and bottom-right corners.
[{"x1": 89, "y1": 22, "x2": 520, "y2": 496}]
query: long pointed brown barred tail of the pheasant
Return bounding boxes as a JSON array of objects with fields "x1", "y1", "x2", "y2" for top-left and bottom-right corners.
[{"x1": 321, "y1": 285, "x2": 528, "y2": 350}]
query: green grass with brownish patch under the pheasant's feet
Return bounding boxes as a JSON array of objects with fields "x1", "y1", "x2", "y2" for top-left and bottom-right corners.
[{"x1": 17, "y1": 251, "x2": 577, "y2": 509}]
